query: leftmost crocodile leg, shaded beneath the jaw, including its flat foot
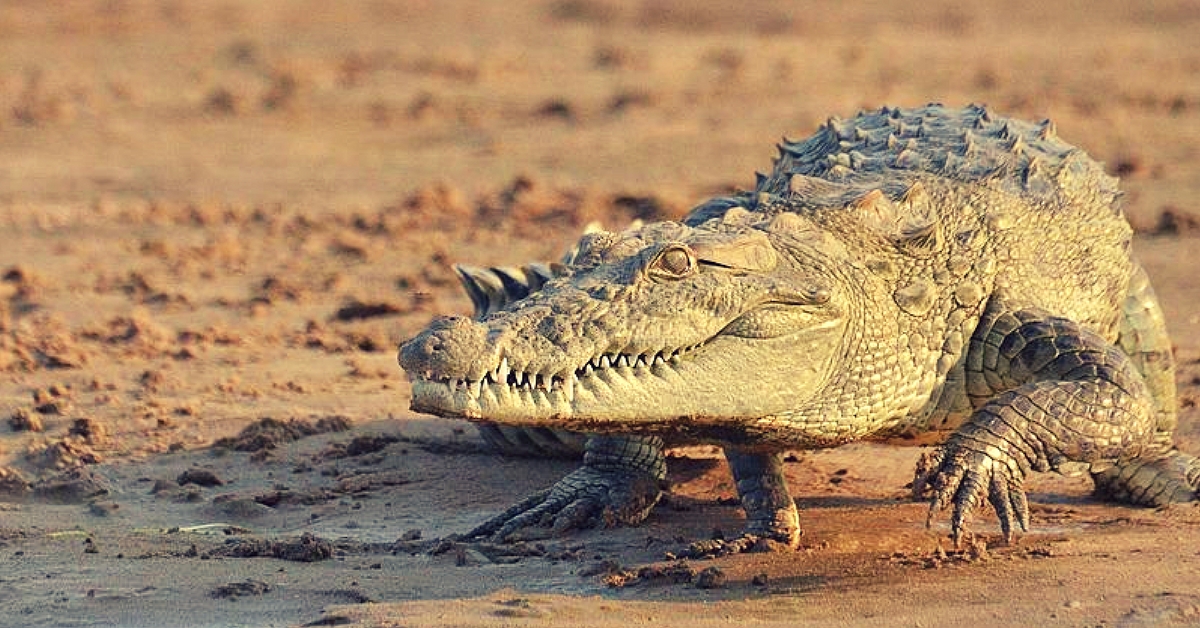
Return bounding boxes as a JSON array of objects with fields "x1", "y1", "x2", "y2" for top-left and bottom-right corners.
[{"x1": 466, "y1": 436, "x2": 666, "y2": 542}]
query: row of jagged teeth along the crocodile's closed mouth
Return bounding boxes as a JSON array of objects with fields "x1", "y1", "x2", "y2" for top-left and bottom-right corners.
[{"x1": 408, "y1": 342, "x2": 707, "y2": 419}]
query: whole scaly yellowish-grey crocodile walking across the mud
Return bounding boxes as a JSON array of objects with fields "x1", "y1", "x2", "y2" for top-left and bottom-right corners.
[{"x1": 398, "y1": 104, "x2": 1200, "y2": 548}]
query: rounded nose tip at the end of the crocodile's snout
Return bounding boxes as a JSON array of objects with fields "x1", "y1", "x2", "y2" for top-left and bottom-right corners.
[{"x1": 400, "y1": 316, "x2": 491, "y2": 379}]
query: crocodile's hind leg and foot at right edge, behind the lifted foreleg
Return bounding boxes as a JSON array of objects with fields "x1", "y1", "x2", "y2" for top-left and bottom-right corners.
[{"x1": 1091, "y1": 267, "x2": 1200, "y2": 507}]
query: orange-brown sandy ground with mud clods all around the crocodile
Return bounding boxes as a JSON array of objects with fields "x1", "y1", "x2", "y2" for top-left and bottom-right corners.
[{"x1": 0, "y1": 0, "x2": 1200, "y2": 626}]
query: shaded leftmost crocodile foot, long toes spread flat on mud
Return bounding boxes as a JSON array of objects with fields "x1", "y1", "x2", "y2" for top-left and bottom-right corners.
[{"x1": 462, "y1": 465, "x2": 661, "y2": 542}]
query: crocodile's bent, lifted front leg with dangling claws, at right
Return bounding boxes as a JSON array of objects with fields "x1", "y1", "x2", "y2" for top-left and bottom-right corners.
[{"x1": 913, "y1": 299, "x2": 1195, "y2": 543}]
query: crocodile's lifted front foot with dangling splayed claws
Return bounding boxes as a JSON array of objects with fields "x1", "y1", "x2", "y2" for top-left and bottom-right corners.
[{"x1": 913, "y1": 443, "x2": 1030, "y2": 546}]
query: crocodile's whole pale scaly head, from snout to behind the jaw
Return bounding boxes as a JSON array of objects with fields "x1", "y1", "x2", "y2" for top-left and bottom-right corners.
[{"x1": 400, "y1": 209, "x2": 846, "y2": 432}]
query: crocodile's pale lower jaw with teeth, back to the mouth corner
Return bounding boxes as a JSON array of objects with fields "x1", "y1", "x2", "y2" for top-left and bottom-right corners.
[{"x1": 401, "y1": 301, "x2": 841, "y2": 430}]
